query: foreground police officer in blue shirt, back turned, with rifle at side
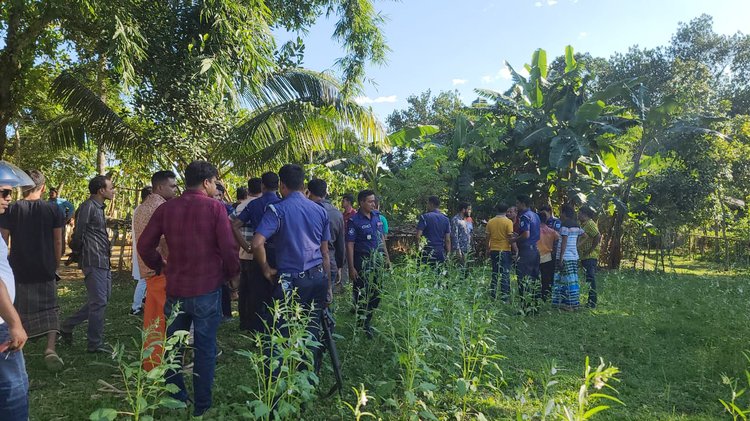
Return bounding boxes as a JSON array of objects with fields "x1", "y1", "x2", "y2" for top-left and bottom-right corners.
[{"x1": 252, "y1": 164, "x2": 331, "y2": 341}]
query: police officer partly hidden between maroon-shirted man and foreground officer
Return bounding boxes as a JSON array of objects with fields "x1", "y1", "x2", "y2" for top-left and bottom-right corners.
[{"x1": 231, "y1": 172, "x2": 281, "y2": 332}]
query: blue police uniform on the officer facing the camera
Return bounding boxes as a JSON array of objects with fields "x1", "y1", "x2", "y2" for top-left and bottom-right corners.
[{"x1": 346, "y1": 210, "x2": 386, "y2": 330}]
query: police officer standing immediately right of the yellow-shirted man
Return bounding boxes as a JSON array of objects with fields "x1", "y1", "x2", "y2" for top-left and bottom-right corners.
[{"x1": 511, "y1": 195, "x2": 541, "y2": 306}]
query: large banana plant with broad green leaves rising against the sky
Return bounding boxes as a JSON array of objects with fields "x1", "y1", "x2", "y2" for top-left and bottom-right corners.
[{"x1": 477, "y1": 46, "x2": 636, "y2": 202}]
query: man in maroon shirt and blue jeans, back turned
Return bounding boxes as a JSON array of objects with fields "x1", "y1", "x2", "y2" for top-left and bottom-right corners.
[{"x1": 137, "y1": 161, "x2": 240, "y2": 417}]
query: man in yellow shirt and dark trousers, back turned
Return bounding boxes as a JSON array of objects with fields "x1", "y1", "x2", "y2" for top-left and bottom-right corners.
[{"x1": 487, "y1": 203, "x2": 515, "y2": 303}]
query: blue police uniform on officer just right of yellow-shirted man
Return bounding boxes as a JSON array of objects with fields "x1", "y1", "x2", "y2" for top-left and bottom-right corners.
[{"x1": 516, "y1": 209, "x2": 541, "y2": 299}]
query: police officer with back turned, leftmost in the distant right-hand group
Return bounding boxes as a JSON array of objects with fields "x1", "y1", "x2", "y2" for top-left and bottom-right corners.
[{"x1": 417, "y1": 196, "x2": 451, "y2": 264}]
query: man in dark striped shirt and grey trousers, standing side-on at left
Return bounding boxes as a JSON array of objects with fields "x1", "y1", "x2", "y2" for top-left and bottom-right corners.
[{"x1": 60, "y1": 175, "x2": 115, "y2": 353}]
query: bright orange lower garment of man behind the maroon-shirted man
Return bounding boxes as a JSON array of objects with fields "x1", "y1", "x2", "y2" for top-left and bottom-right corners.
[{"x1": 143, "y1": 275, "x2": 167, "y2": 371}]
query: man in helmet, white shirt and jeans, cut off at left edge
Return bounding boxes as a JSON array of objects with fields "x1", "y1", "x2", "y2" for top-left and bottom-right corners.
[{"x1": 0, "y1": 166, "x2": 30, "y2": 421}]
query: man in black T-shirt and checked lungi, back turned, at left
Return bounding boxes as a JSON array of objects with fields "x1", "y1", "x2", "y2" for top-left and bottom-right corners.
[{"x1": 0, "y1": 170, "x2": 65, "y2": 371}]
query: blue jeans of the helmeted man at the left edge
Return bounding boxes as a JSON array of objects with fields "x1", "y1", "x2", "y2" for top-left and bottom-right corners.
[{"x1": 0, "y1": 323, "x2": 29, "y2": 421}]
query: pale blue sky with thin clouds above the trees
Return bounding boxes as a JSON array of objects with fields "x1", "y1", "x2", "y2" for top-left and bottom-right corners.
[{"x1": 280, "y1": 0, "x2": 750, "y2": 120}]
